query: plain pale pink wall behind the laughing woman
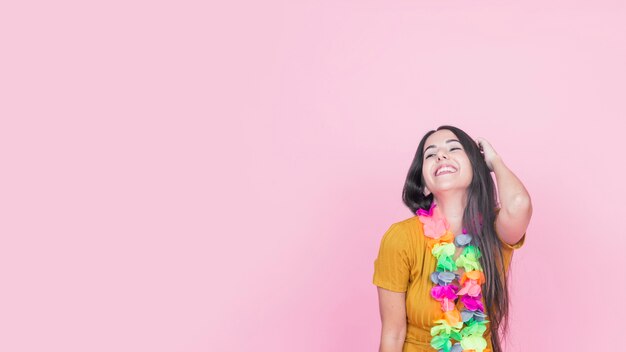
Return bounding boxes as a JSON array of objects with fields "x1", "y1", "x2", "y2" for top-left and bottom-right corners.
[{"x1": 0, "y1": 0, "x2": 626, "y2": 352}]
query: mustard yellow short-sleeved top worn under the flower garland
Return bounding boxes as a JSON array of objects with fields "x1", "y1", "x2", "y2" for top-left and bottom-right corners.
[{"x1": 373, "y1": 213, "x2": 526, "y2": 352}]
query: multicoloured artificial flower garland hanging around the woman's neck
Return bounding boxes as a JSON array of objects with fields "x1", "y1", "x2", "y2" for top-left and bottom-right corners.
[{"x1": 416, "y1": 202, "x2": 489, "y2": 352}]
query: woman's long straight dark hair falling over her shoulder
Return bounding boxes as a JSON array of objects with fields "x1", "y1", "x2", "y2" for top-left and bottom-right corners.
[{"x1": 402, "y1": 125, "x2": 509, "y2": 352}]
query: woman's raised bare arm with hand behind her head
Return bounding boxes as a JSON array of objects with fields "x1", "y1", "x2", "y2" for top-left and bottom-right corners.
[{"x1": 477, "y1": 138, "x2": 533, "y2": 245}]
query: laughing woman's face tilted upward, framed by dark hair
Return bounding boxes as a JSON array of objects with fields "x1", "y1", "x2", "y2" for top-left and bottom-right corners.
[{"x1": 422, "y1": 130, "x2": 473, "y2": 196}]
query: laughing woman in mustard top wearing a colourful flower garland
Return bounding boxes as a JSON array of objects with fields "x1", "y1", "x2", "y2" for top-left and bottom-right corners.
[{"x1": 373, "y1": 125, "x2": 532, "y2": 352}]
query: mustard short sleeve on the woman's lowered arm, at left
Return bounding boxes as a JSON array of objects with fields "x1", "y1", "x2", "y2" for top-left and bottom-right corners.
[{"x1": 373, "y1": 223, "x2": 411, "y2": 292}]
